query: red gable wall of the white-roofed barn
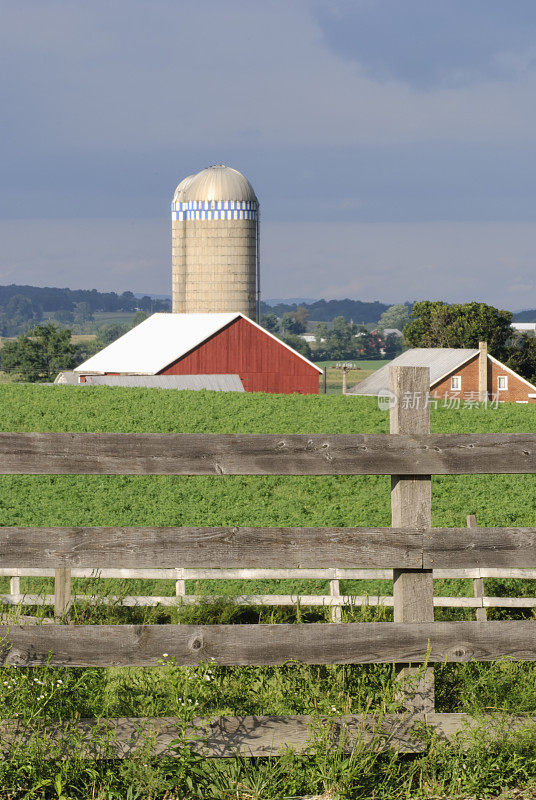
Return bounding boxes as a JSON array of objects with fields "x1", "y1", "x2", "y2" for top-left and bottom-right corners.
[{"x1": 160, "y1": 318, "x2": 319, "y2": 394}]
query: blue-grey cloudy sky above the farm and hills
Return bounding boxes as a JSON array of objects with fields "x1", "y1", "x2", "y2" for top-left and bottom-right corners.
[{"x1": 0, "y1": 0, "x2": 536, "y2": 310}]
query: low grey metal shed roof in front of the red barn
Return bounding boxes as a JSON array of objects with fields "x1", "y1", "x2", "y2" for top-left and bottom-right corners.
[{"x1": 80, "y1": 375, "x2": 245, "y2": 392}]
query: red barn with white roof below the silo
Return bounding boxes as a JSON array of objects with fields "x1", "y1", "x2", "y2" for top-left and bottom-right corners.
[{"x1": 75, "y1": 312, "x2": 322, "y2": 394}]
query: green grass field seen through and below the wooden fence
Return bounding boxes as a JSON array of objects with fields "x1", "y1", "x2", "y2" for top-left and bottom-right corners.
[{"x1": 0, "y1": 384, "x2": 536, "y2": 800}]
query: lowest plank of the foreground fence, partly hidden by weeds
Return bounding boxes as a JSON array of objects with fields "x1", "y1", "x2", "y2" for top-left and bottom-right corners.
[{"x1": 0, "y1": 713, "x2": 536, "y2": 759}]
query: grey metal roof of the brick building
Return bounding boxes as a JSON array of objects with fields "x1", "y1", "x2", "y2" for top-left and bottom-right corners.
[{"x1": 348, "y1": 347, "x2": 479, "y2": 396}]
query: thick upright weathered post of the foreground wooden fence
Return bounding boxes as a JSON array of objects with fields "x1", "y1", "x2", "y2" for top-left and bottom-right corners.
[{"x1": 389, "y1": 366, "x2": 434, "y2": 714}]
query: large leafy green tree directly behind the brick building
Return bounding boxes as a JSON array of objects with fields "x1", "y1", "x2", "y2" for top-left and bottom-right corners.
[{"x1": 404, "y1": 300, "x2": 512, "y2": 359}]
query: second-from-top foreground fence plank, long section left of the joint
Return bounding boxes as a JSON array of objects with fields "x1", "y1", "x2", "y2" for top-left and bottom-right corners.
[{"x1": 0, "y1": 527, "x2": 422, "y2": 569}]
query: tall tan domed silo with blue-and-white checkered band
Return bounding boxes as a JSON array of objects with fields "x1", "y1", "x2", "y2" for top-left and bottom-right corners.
[{"x1": 171, "y1": 164, "x2": 259, "y2": 319}]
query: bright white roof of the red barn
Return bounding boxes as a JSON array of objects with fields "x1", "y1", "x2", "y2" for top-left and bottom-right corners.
[{"x1": 75, "y1": 312, "x2": 322, "y2": 375}]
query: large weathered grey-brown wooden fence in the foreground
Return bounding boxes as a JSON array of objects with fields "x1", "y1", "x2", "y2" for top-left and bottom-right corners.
[{"x1": 0, "y1": 367, "x2": 536, "y2": 756}]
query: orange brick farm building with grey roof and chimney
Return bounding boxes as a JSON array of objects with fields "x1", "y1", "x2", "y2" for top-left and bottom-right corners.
[{"x1": 348, "y1": 342, "x2": 536, "y2": 403}]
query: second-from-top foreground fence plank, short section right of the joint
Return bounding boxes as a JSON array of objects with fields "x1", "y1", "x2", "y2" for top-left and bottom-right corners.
[{"x1": 423, "y1": 527, "x2": 536, "y2": 569}]
